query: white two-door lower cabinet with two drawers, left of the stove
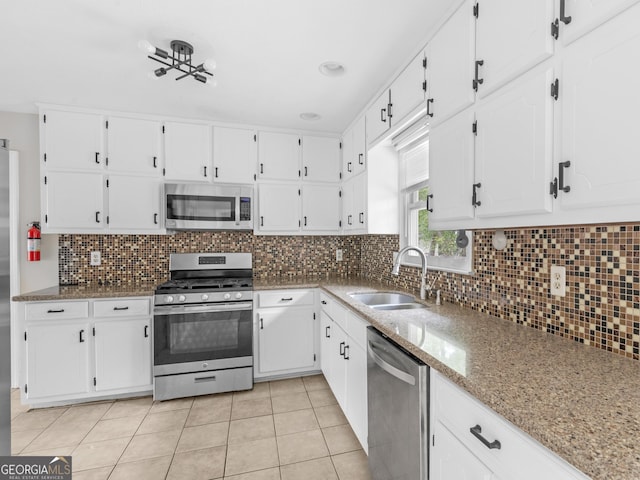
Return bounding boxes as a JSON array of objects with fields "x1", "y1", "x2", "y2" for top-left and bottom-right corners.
[{"x1": 21, "y1": 297, "x2": 152, "y2": 405}]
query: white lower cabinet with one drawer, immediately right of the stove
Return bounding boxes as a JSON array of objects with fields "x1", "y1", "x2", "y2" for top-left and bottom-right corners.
[{"x1": 253, "y1": 290, "x2": 319, "y2": 378}]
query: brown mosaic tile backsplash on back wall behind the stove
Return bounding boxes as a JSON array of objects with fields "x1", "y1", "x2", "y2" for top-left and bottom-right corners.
[{"x1": 58, "y1": 232, "x2": 360, "y2": 285}]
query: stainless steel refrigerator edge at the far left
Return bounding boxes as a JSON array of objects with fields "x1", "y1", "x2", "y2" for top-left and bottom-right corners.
[{"x1": 0, "y1": 139, "x2": 11, "y2": 455}]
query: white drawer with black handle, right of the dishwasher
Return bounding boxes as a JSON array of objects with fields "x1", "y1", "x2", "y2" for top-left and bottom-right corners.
[{"x1": 432, "y1": 375, "x2": 585, "y2": 480}]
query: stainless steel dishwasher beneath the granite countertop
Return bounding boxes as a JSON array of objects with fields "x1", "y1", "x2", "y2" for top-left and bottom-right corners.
[{"x1": 367, "y1": 327, "x2": 429, "y2": 480}]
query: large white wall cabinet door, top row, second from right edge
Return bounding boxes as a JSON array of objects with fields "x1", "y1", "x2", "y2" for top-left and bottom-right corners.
[{"x1": 476, "y1": 0, "x2": 555, "y2": 97}]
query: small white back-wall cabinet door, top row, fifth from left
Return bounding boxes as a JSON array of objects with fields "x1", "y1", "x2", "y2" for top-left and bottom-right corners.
[{"x1": 258, "y1": 132, "x2": 302, "y2": 180}]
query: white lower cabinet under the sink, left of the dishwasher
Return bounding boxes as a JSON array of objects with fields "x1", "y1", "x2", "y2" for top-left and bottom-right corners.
[{"x1": 320, "y1": 293, "x2": 368, "y2": 452}]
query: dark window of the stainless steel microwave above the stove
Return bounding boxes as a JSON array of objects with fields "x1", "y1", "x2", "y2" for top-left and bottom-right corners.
[{"x1": 167, "y1": 195, "x2": 236, "y2": 222}]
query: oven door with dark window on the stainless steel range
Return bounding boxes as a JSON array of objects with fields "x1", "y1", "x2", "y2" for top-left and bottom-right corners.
[{"x1": 153, "y1": 310, "x2": 252, "y2": 365}]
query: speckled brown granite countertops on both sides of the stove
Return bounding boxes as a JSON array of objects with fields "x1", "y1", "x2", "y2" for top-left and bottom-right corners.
[{"x1": 14, "y1": 277, "x2": 640, "y2": 480}]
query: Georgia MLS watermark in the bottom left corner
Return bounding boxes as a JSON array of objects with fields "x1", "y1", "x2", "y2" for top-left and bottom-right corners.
[{"x1": 0, "y1": 457, "x2": 71, "y2": 480}]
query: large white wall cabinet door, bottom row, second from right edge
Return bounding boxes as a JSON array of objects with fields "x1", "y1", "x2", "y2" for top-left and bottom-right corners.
[{"x1": 475, "y1": 68, "x2": 554, "y2": 217}]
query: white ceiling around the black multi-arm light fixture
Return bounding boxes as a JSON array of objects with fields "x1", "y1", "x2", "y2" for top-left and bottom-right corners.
[{"x1": 0, "y1": 0, "x2": 459, "y2": 132}]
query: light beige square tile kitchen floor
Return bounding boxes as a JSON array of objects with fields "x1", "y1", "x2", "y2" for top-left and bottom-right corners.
[{"x1": 11, "y1": 375, "x2": 370, "y2": 480}]
